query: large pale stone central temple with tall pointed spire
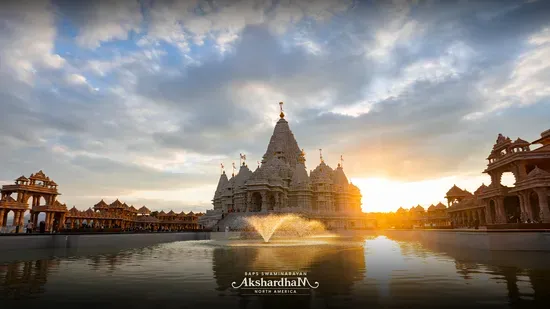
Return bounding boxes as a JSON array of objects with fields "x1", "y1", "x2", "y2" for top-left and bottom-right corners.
[{"x1": 201, "y1": 103, "x2": 378, "y2": 228}]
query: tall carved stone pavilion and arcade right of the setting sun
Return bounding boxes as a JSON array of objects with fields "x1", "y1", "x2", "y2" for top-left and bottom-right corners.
[{"x1": 446, "y1": 130, "x2": 550, "y2": 226}]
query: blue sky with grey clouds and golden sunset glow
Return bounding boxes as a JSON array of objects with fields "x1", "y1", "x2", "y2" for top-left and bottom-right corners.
[{"x1": 0, "y1": 0, "x2": 550, "y2": 212}]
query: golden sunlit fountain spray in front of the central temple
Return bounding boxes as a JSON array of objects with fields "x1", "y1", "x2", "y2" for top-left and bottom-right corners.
[{"x1": 245, "y1": 214, "x2": 325, "y2": 242}]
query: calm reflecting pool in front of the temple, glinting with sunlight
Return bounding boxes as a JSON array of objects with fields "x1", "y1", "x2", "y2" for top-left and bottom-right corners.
[{"x1": 0, "y1": 234, "x2": 550, "y2": 308}]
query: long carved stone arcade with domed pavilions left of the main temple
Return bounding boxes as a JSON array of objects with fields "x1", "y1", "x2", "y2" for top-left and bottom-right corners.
[{"x1": 0, "y1": 171, "x2": 202, "y2": 232}]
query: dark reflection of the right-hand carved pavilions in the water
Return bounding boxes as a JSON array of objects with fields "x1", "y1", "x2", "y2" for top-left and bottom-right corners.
[{"x1": 387, "y1": 233, "x2": 550, "y2": 307}]
